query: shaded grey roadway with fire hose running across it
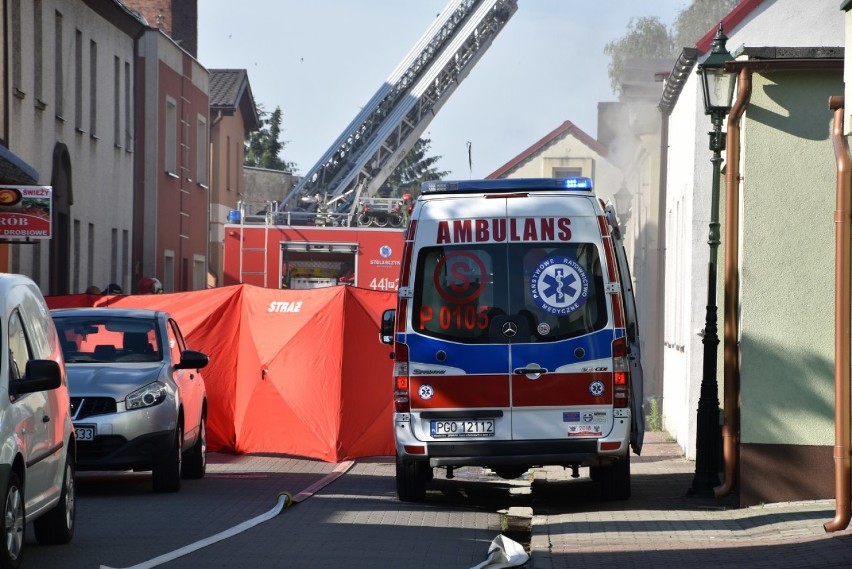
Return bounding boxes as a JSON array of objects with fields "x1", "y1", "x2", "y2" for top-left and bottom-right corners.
[{"x1": 23, "y1": 454, "x2": 529, "y2": 569}]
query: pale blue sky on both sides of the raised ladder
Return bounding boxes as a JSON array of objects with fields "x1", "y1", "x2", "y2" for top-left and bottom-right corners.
[{"x1": 198, "y1": 0, "x2": 690, "y2": 179}]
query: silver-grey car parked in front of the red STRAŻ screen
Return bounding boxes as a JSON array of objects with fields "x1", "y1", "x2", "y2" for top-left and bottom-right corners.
[{"x1": 51, "y1": 308, "x2": 209, "y2": 492}]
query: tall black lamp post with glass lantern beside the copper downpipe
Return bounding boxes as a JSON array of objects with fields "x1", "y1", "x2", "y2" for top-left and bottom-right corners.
[{"x1": 689, "y1": 24, "x2": 736, "y2": 497}]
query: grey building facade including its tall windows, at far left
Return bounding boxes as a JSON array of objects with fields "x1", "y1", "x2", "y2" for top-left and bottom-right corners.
[{"x1": 4, "y1": 0, "x2": 144, "y2": 294}]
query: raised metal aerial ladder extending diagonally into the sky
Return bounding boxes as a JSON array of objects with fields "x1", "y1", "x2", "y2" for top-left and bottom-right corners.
[{"x1": 275, "y1": 0, "x2": 518, "y2": 225}]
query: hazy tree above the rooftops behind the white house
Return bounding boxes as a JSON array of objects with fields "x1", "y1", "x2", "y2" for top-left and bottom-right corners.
[{"x1": 604, "y1": 0, "x2": 742, "y2": 95}]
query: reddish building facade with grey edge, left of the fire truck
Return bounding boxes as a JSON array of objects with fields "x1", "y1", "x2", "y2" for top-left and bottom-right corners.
[{"x1": 133, "y1": 29, "x2": 210, "y2": 292}]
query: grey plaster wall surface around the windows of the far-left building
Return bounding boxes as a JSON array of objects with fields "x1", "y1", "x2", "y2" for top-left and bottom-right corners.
[{"x1": 7, "y1": 0, "x2": 134, "y2": 292}]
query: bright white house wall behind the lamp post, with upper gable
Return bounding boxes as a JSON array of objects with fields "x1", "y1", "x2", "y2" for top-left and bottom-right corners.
[{"x1": 663, "y1": 0, "x2": 843, "y2": 458}]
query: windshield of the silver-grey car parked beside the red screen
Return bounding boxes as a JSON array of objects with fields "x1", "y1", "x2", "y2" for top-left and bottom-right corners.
[{"x1": 54, "y1": 316, "x2": 163, "y2": 364}]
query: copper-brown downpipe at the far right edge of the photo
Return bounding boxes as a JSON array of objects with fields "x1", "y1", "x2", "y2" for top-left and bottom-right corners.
[{"x1": 823, "y1": 97, "x2": 852, "y2": 532}]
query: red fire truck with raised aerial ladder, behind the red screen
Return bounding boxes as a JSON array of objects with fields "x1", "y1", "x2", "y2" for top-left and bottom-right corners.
[{"x1": 224, "y1": 0, "x2": 518, "y2": 290}]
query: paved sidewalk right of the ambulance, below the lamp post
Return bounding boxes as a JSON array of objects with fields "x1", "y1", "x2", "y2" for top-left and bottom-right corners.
[{"x1": 528, "y1": 433, "x2": 852, "y2": 569}]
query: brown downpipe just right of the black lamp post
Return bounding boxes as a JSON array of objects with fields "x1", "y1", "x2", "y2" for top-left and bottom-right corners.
[{"x1": 713, "y1": 69, "x2": 751, "y2": 498}]
